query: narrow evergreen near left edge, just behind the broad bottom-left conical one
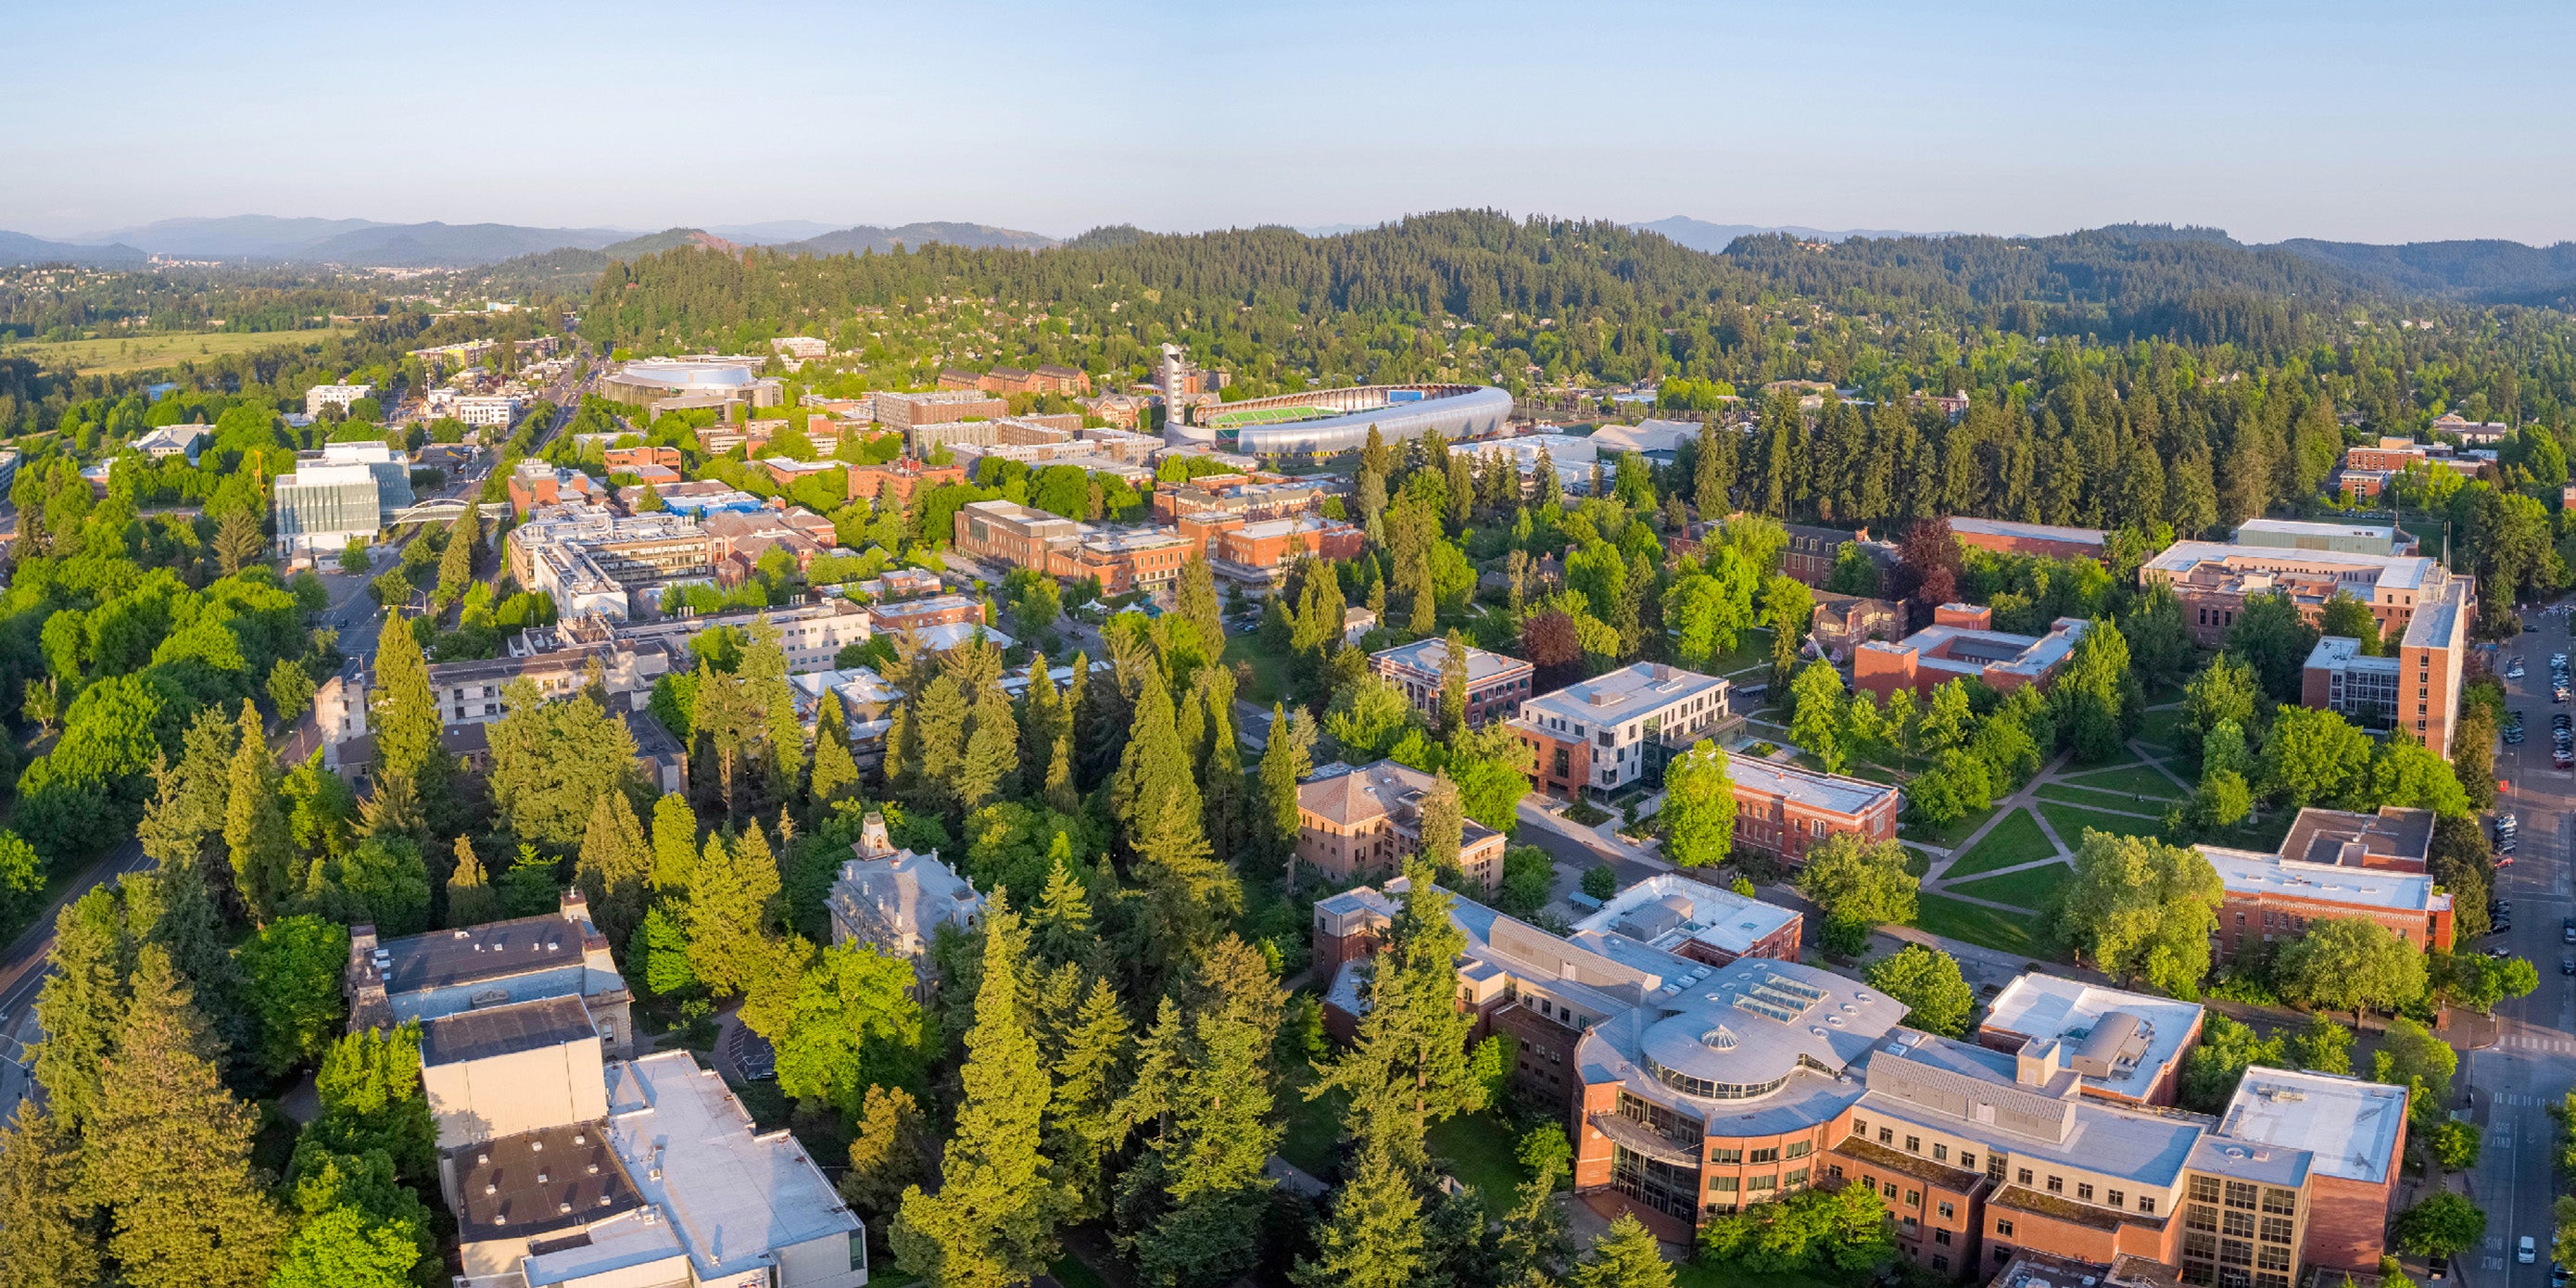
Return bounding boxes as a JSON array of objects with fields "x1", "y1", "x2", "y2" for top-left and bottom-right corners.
[{"x1": 31, "y1": 886, "x2": 134, "y2": 1136}]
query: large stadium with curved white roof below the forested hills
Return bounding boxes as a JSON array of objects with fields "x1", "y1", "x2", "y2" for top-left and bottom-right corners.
[{"x1": 1172, "y1": 384, "x2": 1512, "y2": 456}]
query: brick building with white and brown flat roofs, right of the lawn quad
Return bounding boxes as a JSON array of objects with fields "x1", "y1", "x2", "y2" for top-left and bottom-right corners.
[{"x1": 2200, "y1": 812, "x2": 2453, "y2": 961}]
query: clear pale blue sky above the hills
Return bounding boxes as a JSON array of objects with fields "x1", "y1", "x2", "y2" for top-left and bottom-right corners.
[{"x1": 0, "y1": 0, "x2": 2576, "y2": 242}]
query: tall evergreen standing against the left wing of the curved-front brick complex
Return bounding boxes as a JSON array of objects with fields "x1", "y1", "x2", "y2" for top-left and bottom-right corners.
[{"x1": 1306, "y1": 863, "x2": 1486, "y2": 1175}]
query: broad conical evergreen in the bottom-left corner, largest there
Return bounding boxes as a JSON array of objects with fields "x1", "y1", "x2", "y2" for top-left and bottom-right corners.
[{"x1": 82, "y1": 945, "x2": 286, "y2": 1288}]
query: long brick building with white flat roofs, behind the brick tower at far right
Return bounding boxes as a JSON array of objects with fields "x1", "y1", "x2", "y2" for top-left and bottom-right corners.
[{"x1": 2138, "y1": 541, "x2": 2478, "y2": 647}]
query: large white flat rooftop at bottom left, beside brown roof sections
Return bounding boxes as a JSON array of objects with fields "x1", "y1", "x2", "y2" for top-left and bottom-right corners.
[{"x1": 608, "y1": 1051, "x2": 861, "y2": 1281}]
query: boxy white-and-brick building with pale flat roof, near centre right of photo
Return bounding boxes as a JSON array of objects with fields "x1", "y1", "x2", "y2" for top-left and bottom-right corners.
[{"x1": 1512, "y1": 662, "x2": 1728, "y2": 799}]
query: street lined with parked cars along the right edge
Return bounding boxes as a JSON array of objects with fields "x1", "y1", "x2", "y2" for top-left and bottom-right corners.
[{"x1": 2455, "y1": 613, "x2": 2576, "y2": 1288}]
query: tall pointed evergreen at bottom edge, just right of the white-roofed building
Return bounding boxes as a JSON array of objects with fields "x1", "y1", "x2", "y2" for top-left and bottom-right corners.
[{"x1": 894, "y1": 891, "x2": 1067, "y2": 1288}]
